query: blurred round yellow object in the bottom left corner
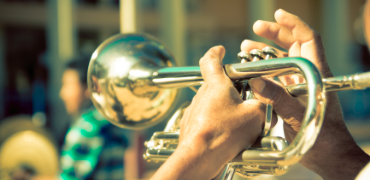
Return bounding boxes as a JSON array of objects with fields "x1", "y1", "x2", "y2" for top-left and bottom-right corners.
[{"x1": 0, "y1": 117, "x2": 59, "y2": 179}]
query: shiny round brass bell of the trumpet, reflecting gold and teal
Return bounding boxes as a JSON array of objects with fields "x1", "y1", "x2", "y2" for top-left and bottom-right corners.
[{"x1": 88, "y1": 34, "x2": 178, "y2": 129}]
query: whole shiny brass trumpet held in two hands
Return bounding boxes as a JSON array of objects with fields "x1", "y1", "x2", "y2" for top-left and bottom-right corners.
[{"x1": 88, "y1": 34, "x2": 370, "y2": 179}]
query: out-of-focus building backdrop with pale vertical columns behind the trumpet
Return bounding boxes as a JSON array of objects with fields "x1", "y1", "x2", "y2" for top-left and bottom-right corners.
[{"x1": 0, "y1": 0, "x2": 370, "y2": 179}]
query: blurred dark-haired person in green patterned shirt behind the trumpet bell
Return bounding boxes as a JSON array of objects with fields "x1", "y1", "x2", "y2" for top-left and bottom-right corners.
[{"x1": 34, "y1": 56, "x2": 129, "y2": 180}]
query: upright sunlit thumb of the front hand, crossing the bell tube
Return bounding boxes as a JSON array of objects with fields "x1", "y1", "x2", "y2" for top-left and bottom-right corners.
[{"x1": 199, "y1": 46, "x2": 227, "y2": 82}]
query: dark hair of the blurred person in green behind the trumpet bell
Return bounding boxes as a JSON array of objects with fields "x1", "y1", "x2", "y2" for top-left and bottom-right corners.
[{"x1": 66, "y1": 55, "x2": 90, "y2": 85}]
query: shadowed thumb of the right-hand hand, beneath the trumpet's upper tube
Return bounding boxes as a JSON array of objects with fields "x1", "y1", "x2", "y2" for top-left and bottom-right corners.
[{"x1": 248, "y1": 78, "x2": 306, "y2": 123}]
